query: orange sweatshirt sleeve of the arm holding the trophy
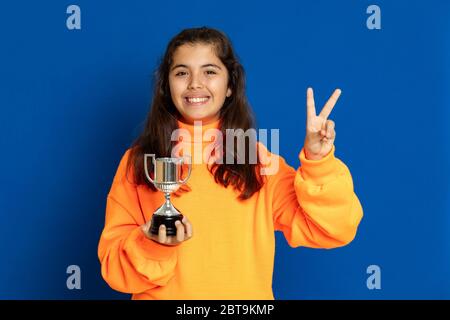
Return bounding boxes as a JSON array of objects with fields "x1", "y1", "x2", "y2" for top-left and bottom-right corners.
[{"x1": 98, "y1": 150, "x2": 177, "y2": 293}]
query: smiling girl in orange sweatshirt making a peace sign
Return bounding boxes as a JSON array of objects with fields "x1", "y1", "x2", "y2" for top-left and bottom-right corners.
[{"x1": 98, "y1": 27, "x2": 363, "y2": 299}]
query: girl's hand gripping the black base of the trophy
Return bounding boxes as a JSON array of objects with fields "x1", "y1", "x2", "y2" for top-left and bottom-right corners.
[{"x1": 141, "y1": 216, "x2": 192, "y2": 246}]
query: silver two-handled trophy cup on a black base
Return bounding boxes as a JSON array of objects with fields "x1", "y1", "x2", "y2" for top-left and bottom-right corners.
[{"x1": 144, "y1": 154, "x2": 192, "y2": 236}]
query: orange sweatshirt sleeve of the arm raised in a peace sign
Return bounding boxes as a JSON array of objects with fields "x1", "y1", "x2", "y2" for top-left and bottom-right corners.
[{"x1": 270, "y1": 146, "x2": 363, "y2": 249}]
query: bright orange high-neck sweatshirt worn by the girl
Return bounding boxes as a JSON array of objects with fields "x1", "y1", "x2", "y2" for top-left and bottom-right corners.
[{"x1": 98, "y1": 121, "x2": 363, "y2": 299}]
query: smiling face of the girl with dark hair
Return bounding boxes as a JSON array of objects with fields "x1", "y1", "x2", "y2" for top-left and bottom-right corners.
[{"x1": 169, "y1": 44, "x2": 231, "y2": 124}]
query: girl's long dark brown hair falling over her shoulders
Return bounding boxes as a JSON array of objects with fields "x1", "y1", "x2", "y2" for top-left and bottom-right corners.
[{"x1": 127, "y1": 27, "x2": 264, "y2": 200}]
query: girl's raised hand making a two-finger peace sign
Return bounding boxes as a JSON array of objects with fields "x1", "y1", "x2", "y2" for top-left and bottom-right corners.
[{"x1": 304, "y1": 88, "x2": 341, "y2": 160}]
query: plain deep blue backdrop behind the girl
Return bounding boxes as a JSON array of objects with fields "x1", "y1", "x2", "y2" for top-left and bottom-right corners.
[{"x1": 0, "y1": 0, "x2": 450, "y2": 299}]
